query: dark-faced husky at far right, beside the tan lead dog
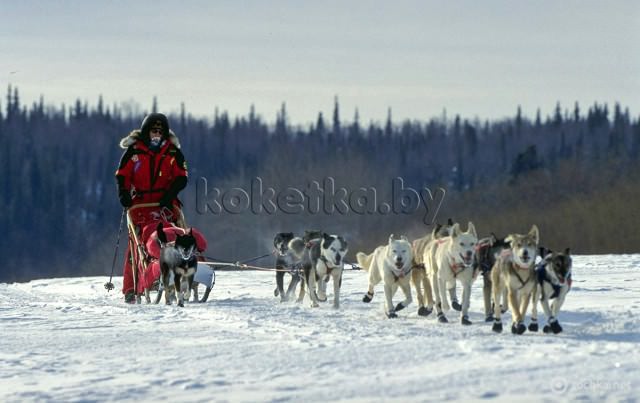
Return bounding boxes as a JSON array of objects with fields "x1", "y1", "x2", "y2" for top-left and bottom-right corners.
[{"x1": 529, "y1": 248, "x2": 572, "y2": 334}]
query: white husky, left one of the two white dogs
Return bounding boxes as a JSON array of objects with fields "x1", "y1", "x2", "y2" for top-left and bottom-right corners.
[{"x1": 356, "y1": 234, "x2": 413, "y2": 318}]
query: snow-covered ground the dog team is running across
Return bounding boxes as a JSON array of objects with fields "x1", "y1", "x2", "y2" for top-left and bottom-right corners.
[{"x1": 0, "y1": 255, "x2": 640, "y2": 402}]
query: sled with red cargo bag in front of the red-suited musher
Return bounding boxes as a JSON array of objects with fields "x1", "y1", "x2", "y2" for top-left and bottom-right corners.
[{"x1": 127, "y1": 203, "x2": 215, "y2": 304}]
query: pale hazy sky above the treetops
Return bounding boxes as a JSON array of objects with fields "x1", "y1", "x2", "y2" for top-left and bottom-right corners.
[{"x1": 0, "y1": 0, "x2": 640, "y2": 124}]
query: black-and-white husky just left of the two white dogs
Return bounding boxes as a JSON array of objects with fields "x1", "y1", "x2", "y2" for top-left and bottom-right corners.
[{"x1": 303, "y1": 233, "x2": 348, "y2": 309}]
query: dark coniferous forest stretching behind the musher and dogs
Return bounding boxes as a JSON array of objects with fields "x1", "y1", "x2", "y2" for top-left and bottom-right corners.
[{"x1": 0, "y1": 86, "x2": 640, "y2": 282}]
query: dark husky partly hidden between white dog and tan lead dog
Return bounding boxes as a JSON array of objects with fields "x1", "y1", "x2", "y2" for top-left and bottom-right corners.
[{"x1": 474, "y1": 233, "x2": 509, "y2": 322}]
